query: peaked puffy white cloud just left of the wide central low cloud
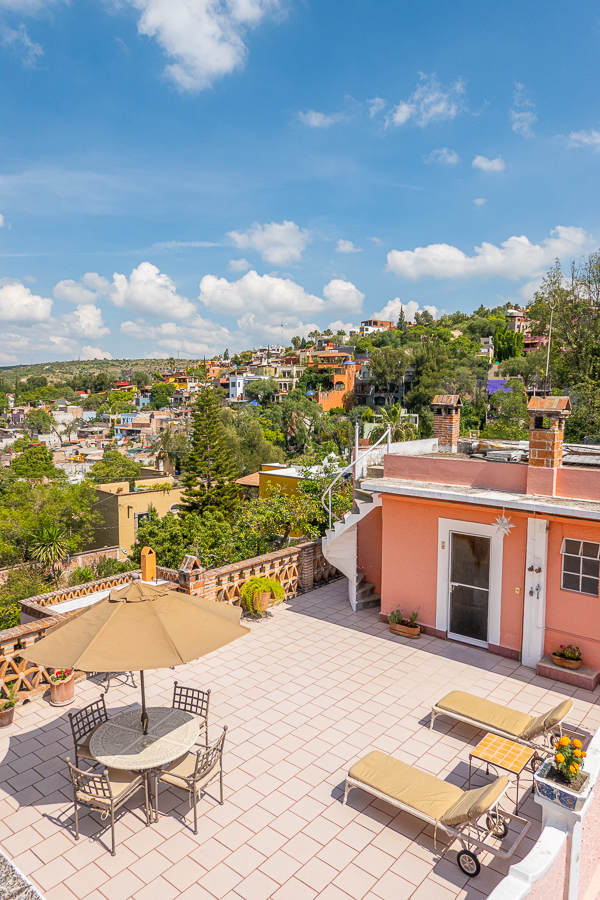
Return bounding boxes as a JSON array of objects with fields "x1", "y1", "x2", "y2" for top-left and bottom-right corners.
[{"x1": 62, "y1": 262, "x2": 196, "y2": 319}]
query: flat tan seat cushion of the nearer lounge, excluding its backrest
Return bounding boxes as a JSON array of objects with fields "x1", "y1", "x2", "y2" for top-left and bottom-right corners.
[{"x1": 348, "y1": 750, "x2": 463, "y2": 819}]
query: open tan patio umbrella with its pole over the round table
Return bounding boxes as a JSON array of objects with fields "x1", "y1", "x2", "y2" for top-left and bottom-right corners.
[{"x1": 26, "y1": 581, "x2": 250, "y2": 734}]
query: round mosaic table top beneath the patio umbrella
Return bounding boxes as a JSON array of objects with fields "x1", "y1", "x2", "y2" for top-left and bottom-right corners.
[{"x1": 90, "y1": 706, "x2": 199, "y2": 772}]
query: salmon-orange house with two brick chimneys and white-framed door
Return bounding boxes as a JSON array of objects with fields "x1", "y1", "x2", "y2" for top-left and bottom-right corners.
[{"x1": 323, "y1": 396, "x2": 600, "y2": 689}]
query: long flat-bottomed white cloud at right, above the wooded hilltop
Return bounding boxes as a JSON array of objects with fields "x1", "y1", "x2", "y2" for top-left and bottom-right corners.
[{"x1": 386, "y1": 225, "x2": 593, "y2": 281}]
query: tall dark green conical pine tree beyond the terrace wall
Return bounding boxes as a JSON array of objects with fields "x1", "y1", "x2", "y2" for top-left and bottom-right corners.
[{"x1": 181, "y1": 384, "x2": 238, "y2": 513}]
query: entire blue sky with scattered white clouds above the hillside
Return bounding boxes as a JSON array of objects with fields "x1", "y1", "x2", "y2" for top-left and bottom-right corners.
[{"x1": 0, "y1": 0, "x2": 600, "y2": 365}]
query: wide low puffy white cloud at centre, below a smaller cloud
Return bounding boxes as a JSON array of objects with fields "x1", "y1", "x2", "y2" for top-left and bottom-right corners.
[{"x1": 199, "y1": 270, "x2": 364, "y2": 328}]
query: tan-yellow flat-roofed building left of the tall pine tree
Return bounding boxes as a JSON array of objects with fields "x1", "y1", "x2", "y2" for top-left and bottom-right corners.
[{"x1": 86, "y1": 475, "x2": 183, "y2": 553}]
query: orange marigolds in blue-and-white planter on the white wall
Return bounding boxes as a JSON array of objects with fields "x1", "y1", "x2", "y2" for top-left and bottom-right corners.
[{"x1": 534, "y1": 735, "x2": 589, "y2": 810}]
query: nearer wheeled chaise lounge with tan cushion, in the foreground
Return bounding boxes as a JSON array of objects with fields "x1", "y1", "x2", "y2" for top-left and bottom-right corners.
[{"x1": 343, "y1": 750, "x2": 531, "y2": 877}]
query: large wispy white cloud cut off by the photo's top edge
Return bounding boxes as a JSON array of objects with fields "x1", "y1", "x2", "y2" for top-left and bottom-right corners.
[{"x1": 123, "y1": 0, "x2": 279, "y2": 91}]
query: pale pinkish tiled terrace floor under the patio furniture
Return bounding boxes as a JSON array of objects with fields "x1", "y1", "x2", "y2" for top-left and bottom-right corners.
[{"x1": 0, "y1": 582, "x2": 600, "y2": 900}]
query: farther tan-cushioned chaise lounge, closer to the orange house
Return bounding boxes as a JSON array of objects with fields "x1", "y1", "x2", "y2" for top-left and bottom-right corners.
[{"x1": 429, "y1": 691, "x2": 573, "y2": 756}]
